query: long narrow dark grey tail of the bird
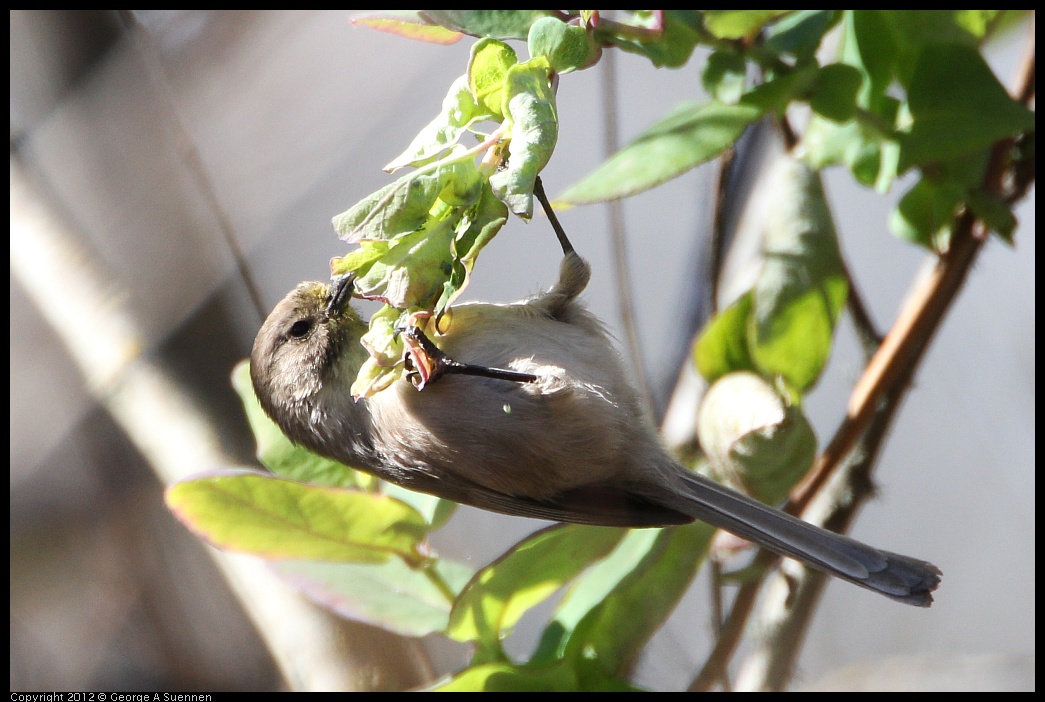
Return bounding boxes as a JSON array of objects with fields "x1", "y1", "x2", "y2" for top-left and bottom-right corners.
[{"x1": 672, "y1": 471, "x2": 941, "y2": 607}]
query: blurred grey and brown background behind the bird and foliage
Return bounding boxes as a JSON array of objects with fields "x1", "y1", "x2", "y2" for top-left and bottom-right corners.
[{"x1": 10, "y1": 10, "x2": 1036, "y2": 691}]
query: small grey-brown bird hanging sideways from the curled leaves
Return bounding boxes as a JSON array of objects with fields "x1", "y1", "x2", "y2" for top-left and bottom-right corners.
[{"x1": 251, "y1": 250, "x2": 941, "y2": 607}]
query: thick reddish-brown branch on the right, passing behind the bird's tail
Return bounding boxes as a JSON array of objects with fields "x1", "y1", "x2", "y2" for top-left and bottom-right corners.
[{"x1": 737, "y1": 28, "x2": 1035, "y2": 691}]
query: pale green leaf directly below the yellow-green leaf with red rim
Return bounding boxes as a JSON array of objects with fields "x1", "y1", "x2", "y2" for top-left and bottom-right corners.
[{"x1": 273, "y1": 558, "x2": 472, "y2": 636}]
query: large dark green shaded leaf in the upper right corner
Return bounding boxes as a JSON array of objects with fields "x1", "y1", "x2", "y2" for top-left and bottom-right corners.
[{"x1": 901, "y1": 44, "x2": 1035, "y2": 169}]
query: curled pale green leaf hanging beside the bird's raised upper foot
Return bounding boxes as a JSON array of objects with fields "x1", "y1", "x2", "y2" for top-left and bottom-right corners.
[{"x1": 490, "y1": 56, "x2": 559, "y2": 219}]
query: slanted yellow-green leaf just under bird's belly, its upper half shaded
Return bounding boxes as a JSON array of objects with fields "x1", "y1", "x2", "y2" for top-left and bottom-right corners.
[{"x1": 447, "y1": 524, "x2": 626, "y2": 649}]
